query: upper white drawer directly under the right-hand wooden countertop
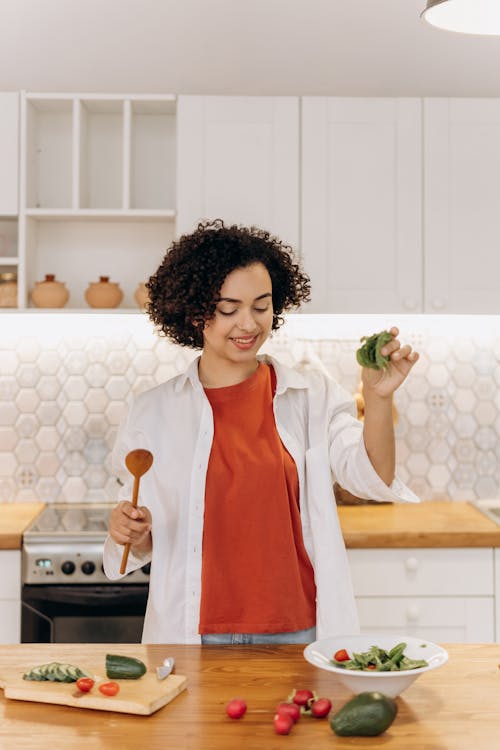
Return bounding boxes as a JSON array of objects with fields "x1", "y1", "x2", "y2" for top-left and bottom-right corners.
[{"x1": 347, "y1": 547, "x2": 494, "y2": 596}]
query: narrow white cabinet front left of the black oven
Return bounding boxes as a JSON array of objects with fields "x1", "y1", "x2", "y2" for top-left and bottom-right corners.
[{"x1": 0, "y1": 550, "x2": 21, "y2": 643}]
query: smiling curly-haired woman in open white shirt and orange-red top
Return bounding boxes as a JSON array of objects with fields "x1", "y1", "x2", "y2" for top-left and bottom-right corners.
[{"x1": 104, "y1": 221, "x2": 418, "y2": 643}]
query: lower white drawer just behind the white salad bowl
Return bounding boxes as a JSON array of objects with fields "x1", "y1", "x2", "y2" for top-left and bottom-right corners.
[{"x1": 356, "y1": 596, "x2": 495, "y2": 645}]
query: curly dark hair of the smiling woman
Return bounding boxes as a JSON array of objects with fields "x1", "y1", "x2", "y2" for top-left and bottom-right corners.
[{"x1": 146, "y1": 219, "x2": 310, "y2": 349}]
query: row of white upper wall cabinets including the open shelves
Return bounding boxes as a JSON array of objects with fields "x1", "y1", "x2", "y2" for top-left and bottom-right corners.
[{"x1": 5, "y1": 92, "x2": 500, "y2": 313}]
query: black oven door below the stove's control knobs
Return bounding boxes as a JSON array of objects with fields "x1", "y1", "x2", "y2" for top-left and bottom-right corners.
[{"x1": 21, "y1": 583, "x2": 149, "y2": 643}]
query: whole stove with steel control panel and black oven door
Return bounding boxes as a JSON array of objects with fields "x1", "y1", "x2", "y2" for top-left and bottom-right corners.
[{"x1": 21, "y1": 503, "x2": 150, "y2": 643}]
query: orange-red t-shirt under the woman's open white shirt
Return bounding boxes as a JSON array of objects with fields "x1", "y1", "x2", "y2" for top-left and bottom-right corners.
[{"x1": 199, "y1": 363, "x2": 316, "y2": 633}]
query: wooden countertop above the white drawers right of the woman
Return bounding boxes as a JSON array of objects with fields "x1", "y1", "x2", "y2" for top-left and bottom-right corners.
[{"x1": 338, "y1": 500, "x2": 500, "y2": 548}]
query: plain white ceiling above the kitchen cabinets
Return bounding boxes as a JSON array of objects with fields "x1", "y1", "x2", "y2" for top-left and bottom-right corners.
[{"x1": 0, "y1": 0, "x2": 500, "y2": 96}]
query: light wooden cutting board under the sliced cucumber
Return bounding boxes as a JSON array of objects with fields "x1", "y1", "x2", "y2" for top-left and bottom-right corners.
[{"x1": 0, "y1": 664, "x2": 187, "y2": 716}]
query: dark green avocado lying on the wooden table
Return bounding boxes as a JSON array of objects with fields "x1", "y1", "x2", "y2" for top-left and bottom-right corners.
[{"x1": 330, "y1": 692, "x2": 398, "y2": 737}]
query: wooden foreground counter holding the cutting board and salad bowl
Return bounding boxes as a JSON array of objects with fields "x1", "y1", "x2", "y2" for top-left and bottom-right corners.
[{"x1": 0, "y1": 644, "x2": 500, "y2": 750}]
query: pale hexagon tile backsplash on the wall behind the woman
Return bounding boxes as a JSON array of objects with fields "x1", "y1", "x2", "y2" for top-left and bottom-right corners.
[{"x1": 0, "y1": 323, "x2": 500, "y2": 502}]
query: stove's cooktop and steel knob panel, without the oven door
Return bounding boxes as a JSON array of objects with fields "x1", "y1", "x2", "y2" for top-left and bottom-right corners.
[{"x1": 22, "y1": 503, "x2": 149, "y2": 585}]
